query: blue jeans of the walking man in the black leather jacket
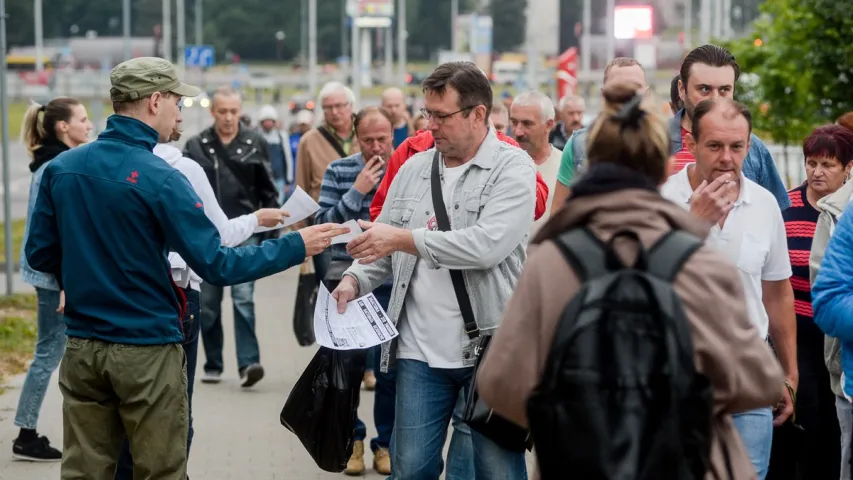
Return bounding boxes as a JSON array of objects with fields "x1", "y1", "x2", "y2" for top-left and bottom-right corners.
[{"x1": 201, "y1": 237, "x2": 261, "y2": 373}]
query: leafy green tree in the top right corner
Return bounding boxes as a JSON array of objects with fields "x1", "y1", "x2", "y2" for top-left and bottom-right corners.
[{"x1": 728, "y1": 0, "x2": 853, "y2": 145}]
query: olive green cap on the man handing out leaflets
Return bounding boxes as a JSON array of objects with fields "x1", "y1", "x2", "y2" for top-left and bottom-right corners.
[{"x1": 110, "y1": 57, "x2": 201, "y2": 102}]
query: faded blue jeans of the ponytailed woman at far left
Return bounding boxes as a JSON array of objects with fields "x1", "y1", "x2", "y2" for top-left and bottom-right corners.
[{"x1": 15, "y1": 288, "x2": 65, "y2": 430}]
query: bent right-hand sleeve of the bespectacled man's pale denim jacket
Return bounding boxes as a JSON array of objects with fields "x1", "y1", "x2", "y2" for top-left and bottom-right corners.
[{"x1": 412, "y1": 156, "x2": 536, "y2": 270}]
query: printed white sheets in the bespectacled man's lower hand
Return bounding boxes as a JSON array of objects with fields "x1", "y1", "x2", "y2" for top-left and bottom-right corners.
[{"x1": 314, "y1": 283, "x2": 399, "y2": 350}]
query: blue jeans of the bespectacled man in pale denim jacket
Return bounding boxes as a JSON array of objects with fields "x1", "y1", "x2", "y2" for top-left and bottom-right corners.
[{"x1": 391, "y1": 360, "x2": 527, "y2": 480}]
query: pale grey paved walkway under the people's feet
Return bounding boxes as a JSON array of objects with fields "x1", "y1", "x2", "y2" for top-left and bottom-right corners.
[{"x1": 0, "y1": 272, "x2": 382, "y2": 480}]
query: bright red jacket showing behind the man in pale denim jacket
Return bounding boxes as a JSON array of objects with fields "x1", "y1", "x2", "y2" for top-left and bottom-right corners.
[{"x1": 370, "y1": 130, "x2": 548, "y2": 221}]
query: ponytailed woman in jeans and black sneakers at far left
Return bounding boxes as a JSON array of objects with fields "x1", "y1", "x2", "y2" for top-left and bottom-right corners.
[{"x1": 12, "y1": 97, "x2": 92, "y2": 462}]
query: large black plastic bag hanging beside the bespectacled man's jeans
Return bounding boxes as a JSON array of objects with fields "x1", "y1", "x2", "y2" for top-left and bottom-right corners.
[{"x1": 280, "y1": 347, "x2": 367, "y2": 473}]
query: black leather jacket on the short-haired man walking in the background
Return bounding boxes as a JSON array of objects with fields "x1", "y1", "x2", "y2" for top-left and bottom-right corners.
[{"x1": 184, "y1": 126, "x2": 280, "y2": 218}]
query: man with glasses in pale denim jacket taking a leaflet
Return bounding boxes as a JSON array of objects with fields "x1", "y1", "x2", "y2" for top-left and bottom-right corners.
[{"x1": 333, "y1": 62, "x2": 536, "y2": 480}]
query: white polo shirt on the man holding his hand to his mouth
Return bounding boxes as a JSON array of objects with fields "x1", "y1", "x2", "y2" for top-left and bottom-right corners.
[{"x1": 661, "y1": 164, "x2": 791, "y2": 338}]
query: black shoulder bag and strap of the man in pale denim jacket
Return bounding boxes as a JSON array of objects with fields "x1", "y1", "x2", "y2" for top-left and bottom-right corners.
[{"x1": 430, "y1": 151, "x2": 533, "y2": 452}]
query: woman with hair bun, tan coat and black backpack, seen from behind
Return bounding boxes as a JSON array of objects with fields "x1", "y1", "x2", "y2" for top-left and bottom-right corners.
[{"x1": 477, "y1": 85, "x2": 784, "y2": 480}]
